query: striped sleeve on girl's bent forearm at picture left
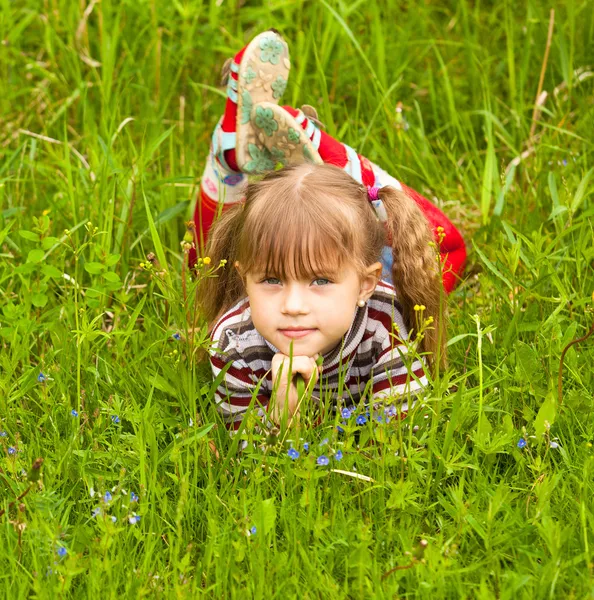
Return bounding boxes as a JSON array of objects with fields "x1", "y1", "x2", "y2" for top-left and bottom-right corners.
[{"x1": 210, "y1": 349, "x2": 270, "y2": 431}]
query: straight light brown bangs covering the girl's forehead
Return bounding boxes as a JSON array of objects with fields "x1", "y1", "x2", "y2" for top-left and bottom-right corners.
[{"x1": 239, "y1": 198, "x2": 356, "y2": 280}]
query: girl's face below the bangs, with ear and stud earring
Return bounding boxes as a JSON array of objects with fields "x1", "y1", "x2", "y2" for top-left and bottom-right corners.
[{"x1": 245, "y1": 262, "x2": 382, "y2": 356}]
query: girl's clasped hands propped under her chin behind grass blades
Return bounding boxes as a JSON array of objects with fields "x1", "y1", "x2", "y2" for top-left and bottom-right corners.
[{"x1": 270, "y1": 352, "x2": 322, "y2": 423}]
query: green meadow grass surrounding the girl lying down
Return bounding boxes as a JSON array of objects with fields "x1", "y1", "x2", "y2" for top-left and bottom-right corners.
[{"x1": 0, "y1": 0, "x2": 594, "y2": 600}]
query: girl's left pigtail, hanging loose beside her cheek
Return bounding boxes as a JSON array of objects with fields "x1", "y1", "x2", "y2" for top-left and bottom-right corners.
[{"x1": 196, "y1": 203, "x2": 245, "y2": 331}]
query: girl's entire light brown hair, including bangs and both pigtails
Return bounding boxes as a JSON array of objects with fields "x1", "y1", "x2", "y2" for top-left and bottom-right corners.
[{"x1": 198, "y1": 163, "x2": 445, "y2": 364}]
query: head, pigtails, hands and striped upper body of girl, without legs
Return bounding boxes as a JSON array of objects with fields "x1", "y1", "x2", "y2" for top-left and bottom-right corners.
[{"x1": 199, "y1": 163, "x2": 445, "y2": 429}]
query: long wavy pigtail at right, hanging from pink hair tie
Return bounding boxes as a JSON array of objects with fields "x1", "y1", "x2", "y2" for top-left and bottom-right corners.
[{"x1": 378, "y1": 187, "x2": 446, "y2": 367}]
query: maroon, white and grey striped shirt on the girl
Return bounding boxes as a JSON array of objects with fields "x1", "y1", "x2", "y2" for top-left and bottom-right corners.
[{"x1": 209, "y1": 281, "x2": 427, "y2": 429}]
